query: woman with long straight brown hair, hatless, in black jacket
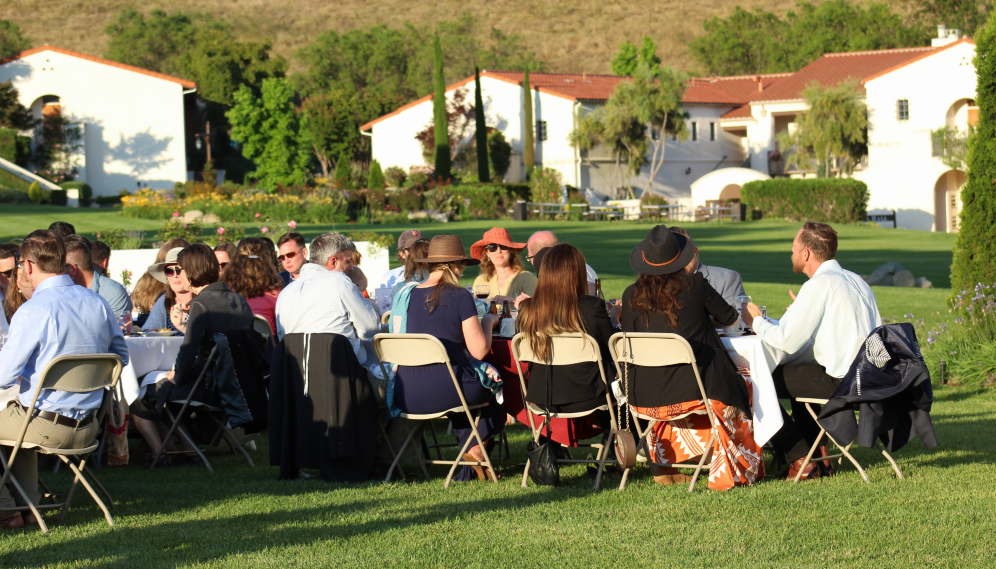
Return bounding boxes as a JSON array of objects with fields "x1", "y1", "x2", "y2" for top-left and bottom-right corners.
[{"x1": 516, "y1": 243, "x2": 615, "y2": 413}]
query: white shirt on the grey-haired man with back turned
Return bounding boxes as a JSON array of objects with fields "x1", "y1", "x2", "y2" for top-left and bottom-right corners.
[{"x1": 276, "y1": 263, "x2": 380, "y2": 367}]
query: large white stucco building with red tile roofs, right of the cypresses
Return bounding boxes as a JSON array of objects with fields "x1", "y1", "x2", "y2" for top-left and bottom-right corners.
[{"x1": 361, "y1": 27, "x2": 977, "y2": 231}]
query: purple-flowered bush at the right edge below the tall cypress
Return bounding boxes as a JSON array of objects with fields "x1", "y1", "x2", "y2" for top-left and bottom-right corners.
[{"x1": 920, "y1": 283, "x2": 996, "y2": 387}]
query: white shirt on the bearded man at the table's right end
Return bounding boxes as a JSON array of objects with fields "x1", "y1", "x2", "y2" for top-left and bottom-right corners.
[{"x1": 754, "y1": 260, "x2": 882, "y2": 378}]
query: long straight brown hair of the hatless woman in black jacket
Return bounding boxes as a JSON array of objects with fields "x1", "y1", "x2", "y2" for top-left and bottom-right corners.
[{"x1": 516, "y1": 243, "x2": 588, "y2": 360}]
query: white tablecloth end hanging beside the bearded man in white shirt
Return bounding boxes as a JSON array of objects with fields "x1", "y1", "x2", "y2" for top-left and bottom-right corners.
[{"x1": 723, "y1": 335, "x2": 782, "y2": 445}]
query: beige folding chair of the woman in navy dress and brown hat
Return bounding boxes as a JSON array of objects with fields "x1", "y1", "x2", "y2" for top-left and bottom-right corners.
[{"x1": 373, "y1": 334, "x2": 498, "y2": 488}]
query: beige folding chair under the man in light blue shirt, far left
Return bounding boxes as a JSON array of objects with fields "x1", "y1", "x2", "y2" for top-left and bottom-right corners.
[{"x1": 0, "y1": 354, "x2": 124, "y2": 533}]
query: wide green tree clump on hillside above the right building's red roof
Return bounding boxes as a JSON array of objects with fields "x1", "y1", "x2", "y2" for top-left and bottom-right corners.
[{"x1": 688, "y1": 0, "x2": 932, "y2": 75}]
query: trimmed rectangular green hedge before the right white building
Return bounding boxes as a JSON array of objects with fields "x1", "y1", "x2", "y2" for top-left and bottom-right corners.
[{"x1": 740, "y1": 178, "x2": 868, "y2": 223}]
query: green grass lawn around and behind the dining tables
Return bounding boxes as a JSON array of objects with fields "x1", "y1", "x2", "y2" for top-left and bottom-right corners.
[{"x1": 0, "y1": 207, "x2": 996, "y2": 569}]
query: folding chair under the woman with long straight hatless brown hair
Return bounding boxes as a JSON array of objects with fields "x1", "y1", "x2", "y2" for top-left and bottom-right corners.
[{"x1": 512, "y1": 333, "x2": 618, "y2": 490}]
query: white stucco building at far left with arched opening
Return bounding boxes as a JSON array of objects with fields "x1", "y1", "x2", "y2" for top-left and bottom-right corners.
[{"x1": 0, "y1": 45, "x2": 196, "y2": 196}]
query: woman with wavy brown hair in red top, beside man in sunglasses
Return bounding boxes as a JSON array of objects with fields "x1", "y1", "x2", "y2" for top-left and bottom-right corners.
[{"x1": 215, "y1": 237, "x2": 284, "y2": 335}]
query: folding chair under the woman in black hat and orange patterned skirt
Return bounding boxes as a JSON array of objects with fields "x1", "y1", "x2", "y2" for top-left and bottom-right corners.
[{"x1": 609, "y1": 332, "x2": 720, "y2": 492}]
